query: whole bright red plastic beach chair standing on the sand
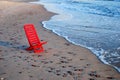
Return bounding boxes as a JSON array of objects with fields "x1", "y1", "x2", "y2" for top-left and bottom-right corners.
[{"x1": 24, "y1": 24, "x2": 47, "y2": 53}]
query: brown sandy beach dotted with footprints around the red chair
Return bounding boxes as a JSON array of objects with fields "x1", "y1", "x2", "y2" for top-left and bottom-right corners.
[{"x1": 0, "y1": 0, "x2": 120, "y2": 80}]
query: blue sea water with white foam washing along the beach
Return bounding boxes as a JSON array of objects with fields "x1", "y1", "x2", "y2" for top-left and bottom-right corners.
[{"x1": 31, "y1": 0, "x2": 120, "y2": 72}]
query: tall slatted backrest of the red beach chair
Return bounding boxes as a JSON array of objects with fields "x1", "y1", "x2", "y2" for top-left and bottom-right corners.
[{"x1": 24, "y1": 24, "x2": 40, "y2": 46}]
